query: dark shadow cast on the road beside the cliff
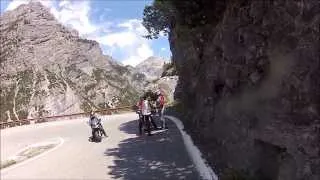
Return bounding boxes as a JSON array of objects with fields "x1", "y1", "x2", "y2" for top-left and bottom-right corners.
[{"x1": 105, "y1": 117, "x2": 199, "y2": 180}]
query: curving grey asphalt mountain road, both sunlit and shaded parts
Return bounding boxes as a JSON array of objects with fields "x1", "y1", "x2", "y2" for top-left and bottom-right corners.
[{"x1": 1, "y1": 113, "x2": 200, "y2": 180}]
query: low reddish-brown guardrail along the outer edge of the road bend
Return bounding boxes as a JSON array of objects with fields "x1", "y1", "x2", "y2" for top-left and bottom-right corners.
[{"x1": 0, "y1": 106, "x2": 133, "y2": 129}]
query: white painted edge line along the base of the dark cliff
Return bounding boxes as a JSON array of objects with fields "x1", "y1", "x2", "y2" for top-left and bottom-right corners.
[{"x1": 165, "y1": 115, "x2": 218, "y2": 180}]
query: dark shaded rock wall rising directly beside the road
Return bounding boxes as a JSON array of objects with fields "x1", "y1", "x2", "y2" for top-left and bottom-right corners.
[{"x1": 169, "y1": 0, "x2": 320, "y2": 180}]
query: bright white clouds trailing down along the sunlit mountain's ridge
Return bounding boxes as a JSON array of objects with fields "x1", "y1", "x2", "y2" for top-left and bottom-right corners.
[{"x1": 6, "y1": 0, "x2": 154, "y2": 66}]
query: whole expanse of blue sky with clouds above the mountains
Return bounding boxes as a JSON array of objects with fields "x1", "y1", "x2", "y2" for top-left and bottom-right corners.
[{"x1": 0, "y1": 0, "x2": 171, "y2": 66}]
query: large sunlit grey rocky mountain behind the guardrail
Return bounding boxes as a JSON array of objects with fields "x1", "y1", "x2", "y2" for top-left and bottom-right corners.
[{"x1": 0, "y1": 3, "x2": 144, "y2": 120}]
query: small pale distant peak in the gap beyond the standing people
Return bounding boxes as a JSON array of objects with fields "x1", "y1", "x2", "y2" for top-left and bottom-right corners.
[{"x1": 135, "y1": 56, "x2": 165, "y2": 81}]
